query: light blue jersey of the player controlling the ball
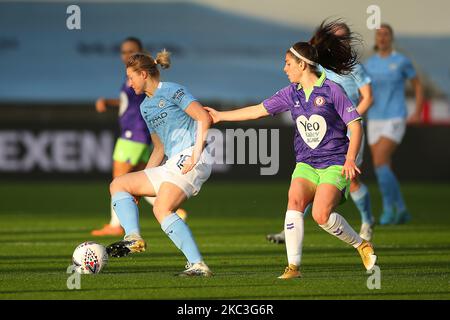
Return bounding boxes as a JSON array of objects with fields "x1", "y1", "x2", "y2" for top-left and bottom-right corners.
[{"x1": 141, "y1": 82, "x2": 197, "y2": 158}]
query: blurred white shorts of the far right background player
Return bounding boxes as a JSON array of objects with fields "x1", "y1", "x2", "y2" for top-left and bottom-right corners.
[{"x1": 367, "y1": 118, "x2": 406, "y2": 145}]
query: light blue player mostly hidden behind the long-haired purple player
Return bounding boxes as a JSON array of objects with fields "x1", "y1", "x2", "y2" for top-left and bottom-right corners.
[{"x1": 267, "y1": 22, "x2": 375, "y2": 243}]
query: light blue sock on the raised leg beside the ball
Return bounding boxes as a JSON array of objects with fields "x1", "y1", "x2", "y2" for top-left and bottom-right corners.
[{"x1": 111, "y1": 192, "x2": 140, "y2": 235}]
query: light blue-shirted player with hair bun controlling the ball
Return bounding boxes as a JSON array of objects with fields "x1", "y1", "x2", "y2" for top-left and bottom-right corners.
[{"x1": 107, "y1": 51, "x2": 212, "y2": 276}]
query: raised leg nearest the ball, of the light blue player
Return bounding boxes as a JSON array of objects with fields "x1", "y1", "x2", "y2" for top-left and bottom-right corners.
[{"x1": 107, "y1": 171, "x2": 155, "y2": 257}]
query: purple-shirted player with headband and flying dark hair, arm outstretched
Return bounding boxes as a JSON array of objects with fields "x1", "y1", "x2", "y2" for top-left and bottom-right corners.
[{"x1": 207, "y1": 22, "x2": 376, "y2": 279}]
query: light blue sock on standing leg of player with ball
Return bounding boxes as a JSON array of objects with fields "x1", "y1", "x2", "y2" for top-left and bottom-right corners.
[{"x1": 161, "y1": 213, "x2": 203, "y2": 264}]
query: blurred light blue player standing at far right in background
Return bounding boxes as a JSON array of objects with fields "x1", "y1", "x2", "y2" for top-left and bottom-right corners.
[{"x1": 365, "y1": 24, "x2": 423, "y2": 225}]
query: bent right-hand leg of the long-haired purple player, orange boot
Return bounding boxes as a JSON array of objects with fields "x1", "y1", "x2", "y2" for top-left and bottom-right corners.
[{"x1": 313, "y1": 183, "x2": 377, "y2": 270}]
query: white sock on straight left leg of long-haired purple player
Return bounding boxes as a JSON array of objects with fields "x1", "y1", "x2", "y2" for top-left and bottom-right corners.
[{"x1": 284, "y1": 210, "x2": 304, "y2": 267}]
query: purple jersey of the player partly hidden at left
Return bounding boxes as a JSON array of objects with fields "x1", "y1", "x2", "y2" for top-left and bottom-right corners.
[{"x1": 119, "y1": 82, "x2": 150, "y2": 144}]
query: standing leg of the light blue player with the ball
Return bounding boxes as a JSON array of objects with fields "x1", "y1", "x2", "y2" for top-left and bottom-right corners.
[{"x1": 153, "y1": 182, "x2": 212, "y2": 276}]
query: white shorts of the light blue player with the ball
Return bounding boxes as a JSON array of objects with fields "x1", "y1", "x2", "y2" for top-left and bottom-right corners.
[{"x1": 144, "y1": 147, "x2": 212, "y2": 198}]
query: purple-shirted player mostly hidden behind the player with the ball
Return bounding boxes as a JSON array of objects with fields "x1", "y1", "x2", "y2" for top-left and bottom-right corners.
[{"x1": 91, "y1": 37, "x2": 186, "y2": 236}]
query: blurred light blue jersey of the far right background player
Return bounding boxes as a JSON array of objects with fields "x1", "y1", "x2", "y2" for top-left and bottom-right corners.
[{"x1": 364, "y1": 51, "x2": 416, "y2": 120}]
